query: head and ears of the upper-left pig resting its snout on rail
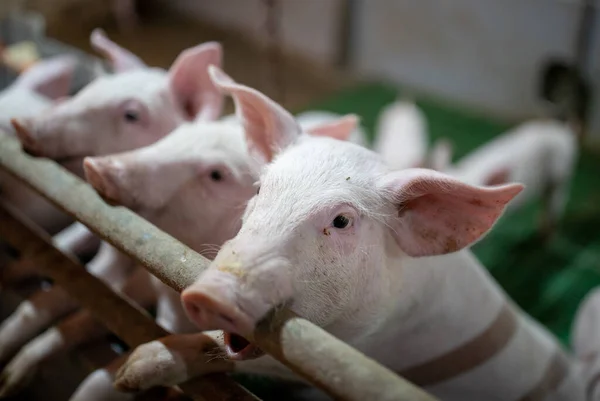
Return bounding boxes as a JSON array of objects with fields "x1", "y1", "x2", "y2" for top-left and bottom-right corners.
[{"x1": 13, "y1": 31, "x2": 223, "y2": 166}]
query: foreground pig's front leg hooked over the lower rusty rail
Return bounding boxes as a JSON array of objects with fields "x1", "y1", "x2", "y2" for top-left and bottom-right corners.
[{"x1": 114, "y1": 331, "x2": 235, "y2": 392}]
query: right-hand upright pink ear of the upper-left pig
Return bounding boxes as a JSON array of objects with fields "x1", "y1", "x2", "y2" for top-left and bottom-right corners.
[{"x1": 169, "y1": 42, "x2": 223, "y2": 121}]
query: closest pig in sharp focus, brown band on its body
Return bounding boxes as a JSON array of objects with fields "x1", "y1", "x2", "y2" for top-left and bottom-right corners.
[{"x1": 115, "y1": 67, "x2": 585, "y2": 401}]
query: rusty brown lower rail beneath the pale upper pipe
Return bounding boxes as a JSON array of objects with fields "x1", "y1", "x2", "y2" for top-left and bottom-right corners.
[{"x1": 0, "y1": 201, "x2": 257, "y2": 401}]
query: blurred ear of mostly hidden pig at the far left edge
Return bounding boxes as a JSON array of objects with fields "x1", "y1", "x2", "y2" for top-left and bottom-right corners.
[{"x1": 16, "y1": 56, "x2": 77, "y2": 99}]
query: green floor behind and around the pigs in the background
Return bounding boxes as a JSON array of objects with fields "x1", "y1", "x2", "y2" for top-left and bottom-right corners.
[{"x1": 300, "y1": 84, "x2": 600, "y2": 344}]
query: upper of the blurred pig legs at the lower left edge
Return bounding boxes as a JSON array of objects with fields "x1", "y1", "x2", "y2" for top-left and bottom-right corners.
[{"x1": 0, "y1": 287, "x2": 77, "y2": 362}]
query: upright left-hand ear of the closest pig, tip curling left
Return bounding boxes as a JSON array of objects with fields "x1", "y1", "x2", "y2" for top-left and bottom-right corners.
[{"x1": 209, "y1": 65, "x2": 301, "y2": 162}]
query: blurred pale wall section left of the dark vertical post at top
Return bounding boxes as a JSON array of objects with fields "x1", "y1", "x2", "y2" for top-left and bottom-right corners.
[{"x1": 166, "y1": 0, "x2": 342, "y2": 63}]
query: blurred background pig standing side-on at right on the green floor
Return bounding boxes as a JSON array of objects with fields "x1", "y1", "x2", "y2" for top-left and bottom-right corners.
[{"x1": 426, "y1": 119, "x2": 578, "y2": 235}]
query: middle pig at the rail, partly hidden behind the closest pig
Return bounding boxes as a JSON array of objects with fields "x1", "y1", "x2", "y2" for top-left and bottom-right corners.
[{"x1": 0, "y1": 111, "x2": 358, "y2": 397}]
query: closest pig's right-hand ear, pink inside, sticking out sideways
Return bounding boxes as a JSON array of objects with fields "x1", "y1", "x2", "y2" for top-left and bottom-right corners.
[{"x1": 380, "y1": 169, "x2": 523, "y2": 257}]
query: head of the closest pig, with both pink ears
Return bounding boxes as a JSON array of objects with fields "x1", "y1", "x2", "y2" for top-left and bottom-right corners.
[{"x1": 182, "y1": 68, "x2": 522, "y2": 359}]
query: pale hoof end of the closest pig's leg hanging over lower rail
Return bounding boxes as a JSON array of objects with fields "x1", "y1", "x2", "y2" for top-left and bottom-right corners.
[{"x1": 115, "y1": 341, "x2": 186, "y2": 392}]
